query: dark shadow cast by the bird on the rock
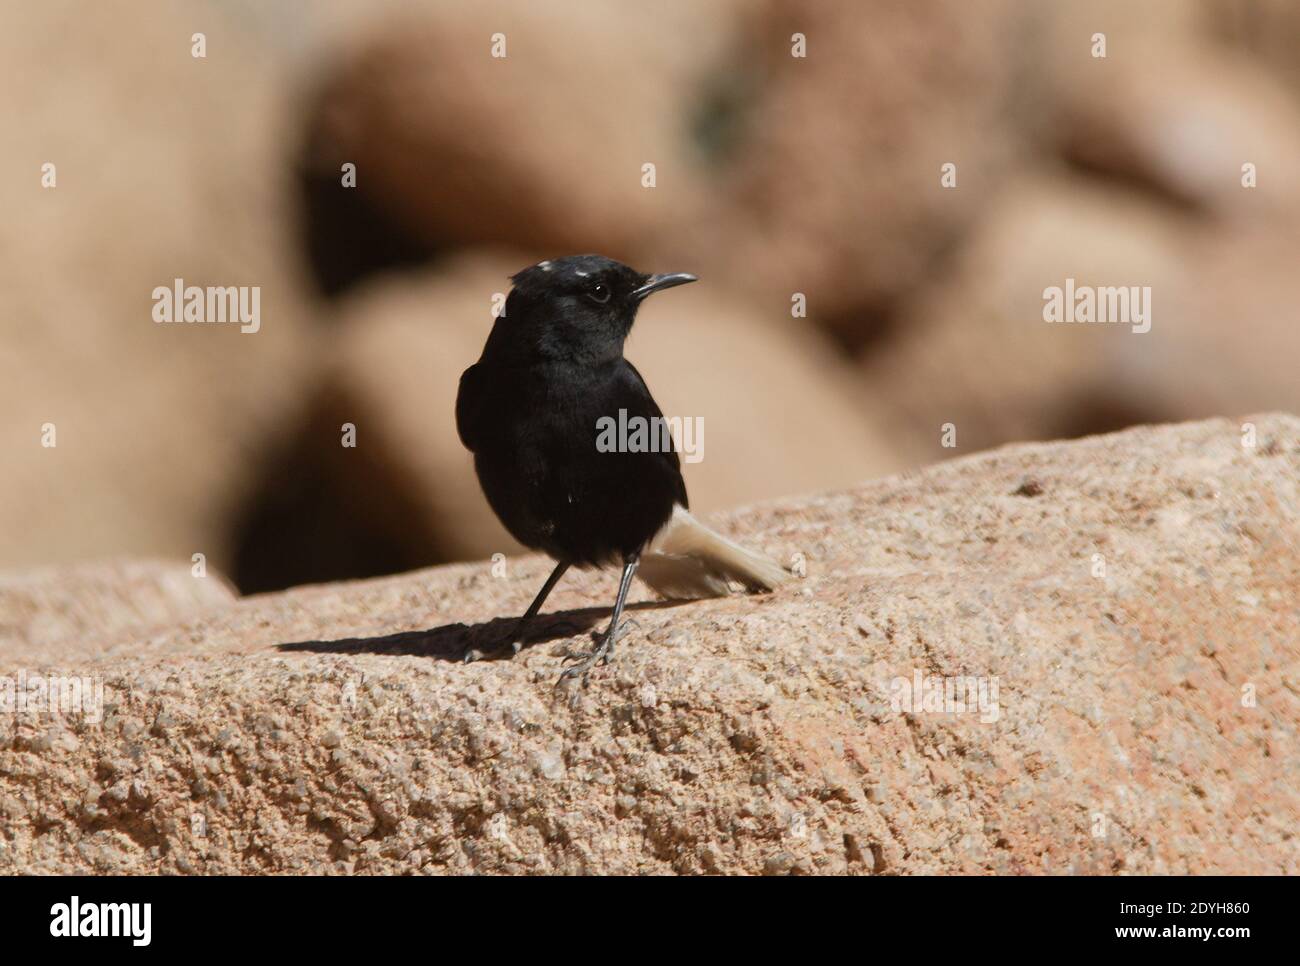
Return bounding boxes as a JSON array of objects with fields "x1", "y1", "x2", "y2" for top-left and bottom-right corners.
[{"x1": 276, "y1": 601, "x2": 680, "y2": 660}]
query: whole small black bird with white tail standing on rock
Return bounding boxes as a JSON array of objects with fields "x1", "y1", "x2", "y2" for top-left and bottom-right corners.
[{"x1": 456, "y1": 255, "x2": 789, "y2": 680}]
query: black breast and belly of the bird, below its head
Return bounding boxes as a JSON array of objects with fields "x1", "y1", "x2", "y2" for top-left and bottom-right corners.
[{"x1": 456, "y1": 359, "x2": 686, "y2": 564}]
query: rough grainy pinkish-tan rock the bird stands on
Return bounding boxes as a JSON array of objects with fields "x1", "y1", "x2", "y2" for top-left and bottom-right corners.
[{"x1": 0, "y1": 415, "x2": 1300, "y2": 874}]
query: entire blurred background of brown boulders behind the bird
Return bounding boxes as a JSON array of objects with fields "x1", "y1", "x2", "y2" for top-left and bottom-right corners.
[{"x1": 0, "y1": 0, "x2": 1300, "y2": 593}]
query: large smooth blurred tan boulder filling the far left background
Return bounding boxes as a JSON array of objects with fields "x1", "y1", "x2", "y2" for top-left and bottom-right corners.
[{"x1": 0, "y1": 0, "x2": 311, "y2": 567}]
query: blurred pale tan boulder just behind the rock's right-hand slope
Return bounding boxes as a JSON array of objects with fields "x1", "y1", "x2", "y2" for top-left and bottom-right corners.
[{"x1": 863, "y1": 176, "x2": 1204, "y2": 459}]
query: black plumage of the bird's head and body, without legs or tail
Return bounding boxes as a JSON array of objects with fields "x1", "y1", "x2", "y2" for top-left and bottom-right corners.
[{"x1": 456, "y1": 255, "x2": 693, "y2": 566}]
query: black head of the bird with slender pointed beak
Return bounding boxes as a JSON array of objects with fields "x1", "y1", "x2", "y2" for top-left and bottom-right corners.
[{"x1": 504, "y1": 255, "x2": 696, "y2": 360}]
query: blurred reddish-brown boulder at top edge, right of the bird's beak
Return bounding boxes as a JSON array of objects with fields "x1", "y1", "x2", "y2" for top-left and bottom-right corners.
[{"x1": 686, "y1": 0, "x2": 1036, "y2": 345}]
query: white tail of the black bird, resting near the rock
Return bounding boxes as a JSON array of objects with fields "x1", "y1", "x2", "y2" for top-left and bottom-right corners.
[{"x1": 637, "y1": 506, "x2": 790, "y2": 601}]
